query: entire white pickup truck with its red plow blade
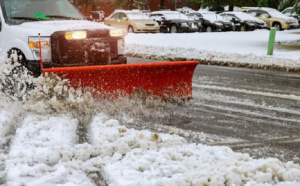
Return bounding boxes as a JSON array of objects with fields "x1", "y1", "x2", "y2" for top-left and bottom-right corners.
[{"x1": 0, "y1": 0, "x2": 198, "y2": 99}]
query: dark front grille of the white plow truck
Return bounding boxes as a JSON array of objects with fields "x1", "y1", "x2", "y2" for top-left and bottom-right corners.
[{"x1": 51, "y1": 30, "x2": 118, "y2": 67}]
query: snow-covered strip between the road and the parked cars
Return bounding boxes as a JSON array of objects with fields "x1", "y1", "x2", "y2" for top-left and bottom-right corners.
[{"x1": 126, "y1": 30, "x2": 300, "y2": 71}]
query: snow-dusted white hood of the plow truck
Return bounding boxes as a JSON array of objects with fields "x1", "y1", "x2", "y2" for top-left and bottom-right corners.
[{"x1": 16, "y1": 20, "x2": 111, "y2": 36}]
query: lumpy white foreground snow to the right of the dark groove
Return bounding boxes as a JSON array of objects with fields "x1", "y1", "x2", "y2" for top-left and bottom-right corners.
[{"x1": 89, "y1": 115, "x2": 300, "y2": 185}]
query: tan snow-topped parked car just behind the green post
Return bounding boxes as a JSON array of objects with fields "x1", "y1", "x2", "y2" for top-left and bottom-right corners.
[{"x1": 240, "y1": 7, "x2": 299, "y2": 30}]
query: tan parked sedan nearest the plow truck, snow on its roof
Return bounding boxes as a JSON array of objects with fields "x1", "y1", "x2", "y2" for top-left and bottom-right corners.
[{"x1": 104, "y1": 10, "x2": 160, "y2": 33}]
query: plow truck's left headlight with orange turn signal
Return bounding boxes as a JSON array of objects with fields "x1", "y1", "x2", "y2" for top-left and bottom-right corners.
[{"x1": 28, "y1": 37, "x2": 52, "y2": 62}]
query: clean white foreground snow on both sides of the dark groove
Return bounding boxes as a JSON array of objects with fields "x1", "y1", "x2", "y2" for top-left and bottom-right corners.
[{"x1": 2, "y1": 109, "x2": 300, "y2": 186}]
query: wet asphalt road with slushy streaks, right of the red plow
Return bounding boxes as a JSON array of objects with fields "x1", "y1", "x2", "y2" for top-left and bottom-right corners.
[{"x1": 128, "y1": 58, "x2": 300, "y2": 163}]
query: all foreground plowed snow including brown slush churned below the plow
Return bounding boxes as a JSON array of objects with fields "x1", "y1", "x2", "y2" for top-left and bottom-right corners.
[{"x1": 0, "y1": 64, "x2": 300, "y2": 186}]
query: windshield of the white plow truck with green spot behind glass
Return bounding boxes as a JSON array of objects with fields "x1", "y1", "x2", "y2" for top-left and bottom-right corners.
[{"x1": 1, "y1": 0, "x2": 84, "y2": 24}]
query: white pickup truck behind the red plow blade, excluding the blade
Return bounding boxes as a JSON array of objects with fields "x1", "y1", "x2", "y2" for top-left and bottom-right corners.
[{"x1": 0, "y1": 0, "x2": 126, "y2": 75}]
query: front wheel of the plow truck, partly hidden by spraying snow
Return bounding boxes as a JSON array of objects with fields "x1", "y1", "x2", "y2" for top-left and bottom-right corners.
[{"x1": 0, "y1": 49, "x2": 34, "y2": 101}]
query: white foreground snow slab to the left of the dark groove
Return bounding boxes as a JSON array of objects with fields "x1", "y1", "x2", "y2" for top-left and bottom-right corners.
[{"x1": 5, "y1": 114, "x2": 96, "y2": 185}]
